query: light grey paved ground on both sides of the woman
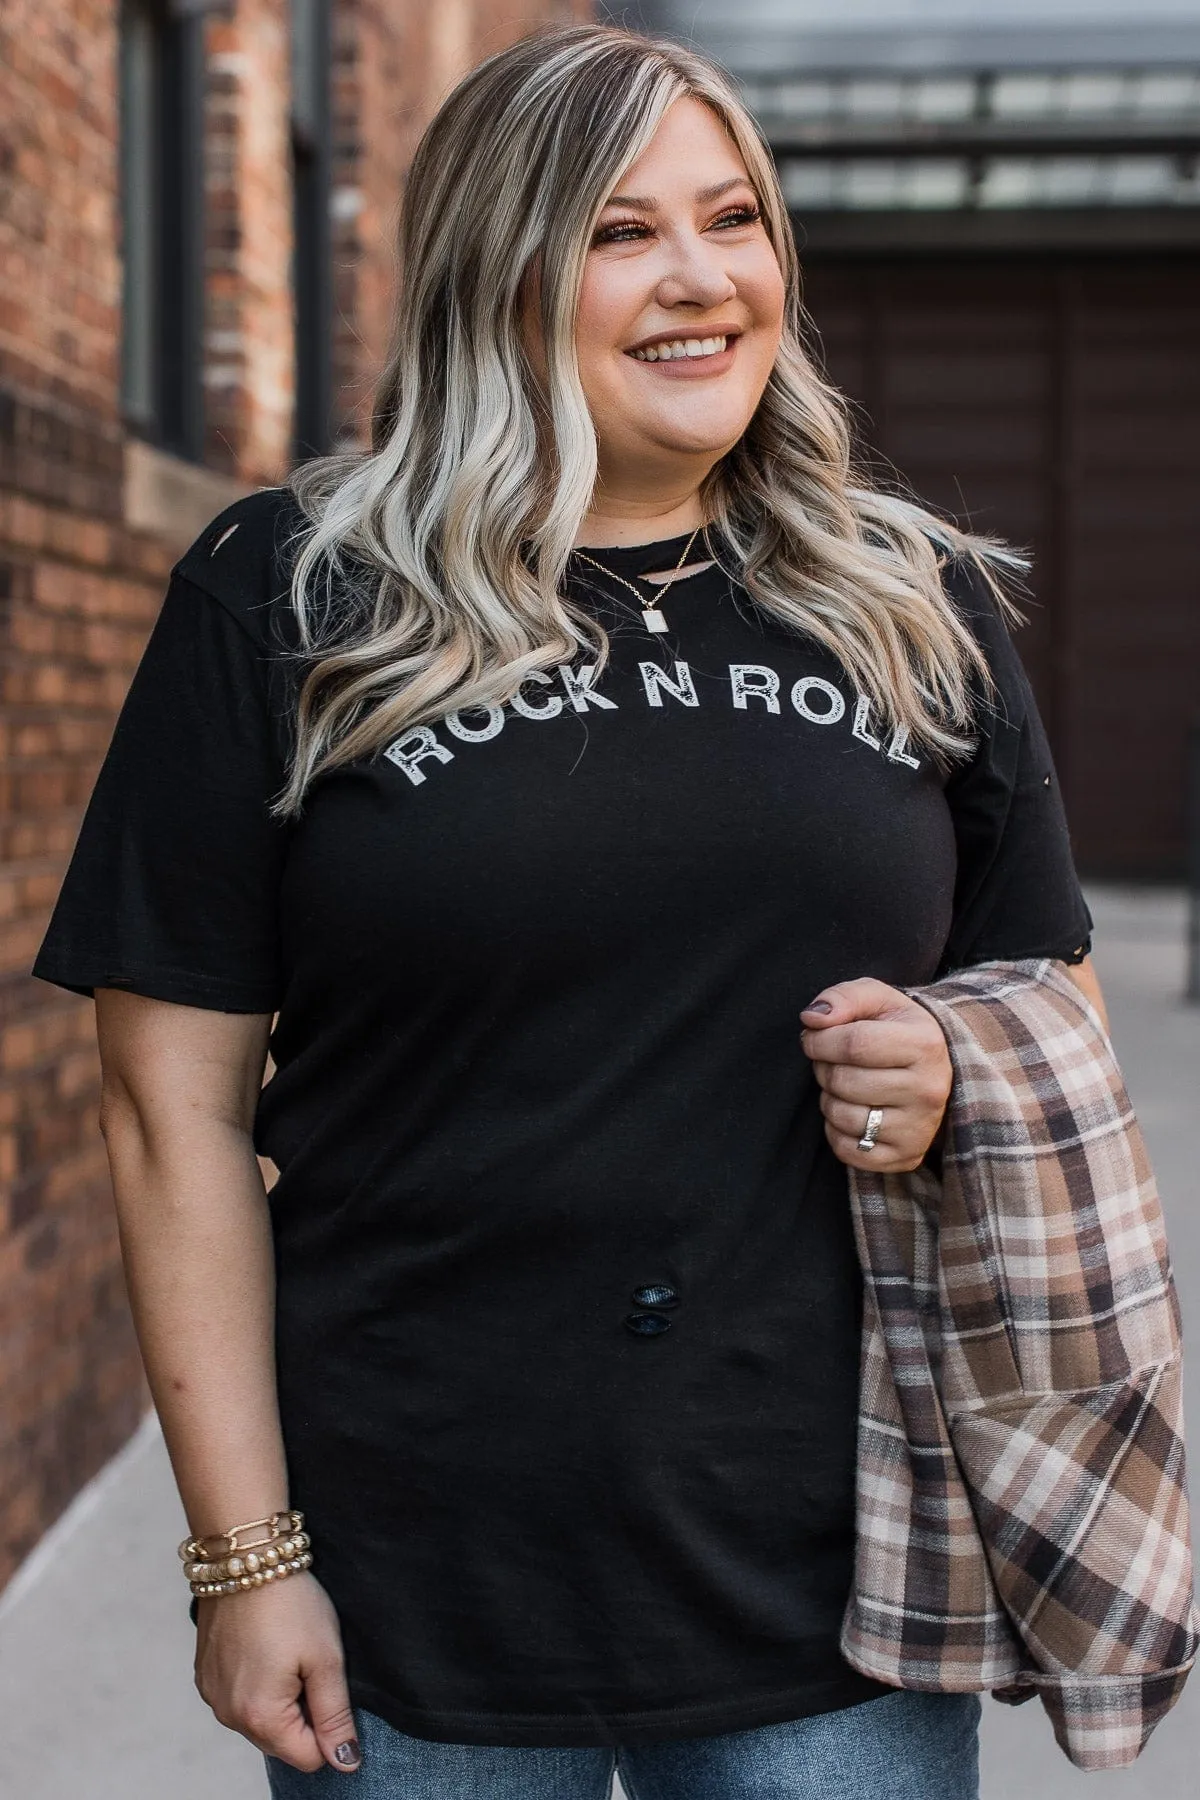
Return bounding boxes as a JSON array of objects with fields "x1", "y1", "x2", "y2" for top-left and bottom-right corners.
[{"x1": 0, "y1": 889, "x2": 1200, "y2": 1800}]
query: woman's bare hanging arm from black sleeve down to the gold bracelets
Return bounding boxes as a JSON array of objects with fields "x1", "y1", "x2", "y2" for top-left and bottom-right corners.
[{"x1": 95, "y1": 988, "x2": 288, "y2": 1534}]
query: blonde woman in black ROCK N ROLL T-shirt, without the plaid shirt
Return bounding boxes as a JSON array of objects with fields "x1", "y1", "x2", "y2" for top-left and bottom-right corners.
[{"x1": 34, "y1": 27, "x2": 1099, "y2": 1800}]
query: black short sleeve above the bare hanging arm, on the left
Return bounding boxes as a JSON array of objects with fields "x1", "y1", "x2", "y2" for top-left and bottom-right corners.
[{"x1": 32, "y1": 571, "x2": 288, "y2": 1012}]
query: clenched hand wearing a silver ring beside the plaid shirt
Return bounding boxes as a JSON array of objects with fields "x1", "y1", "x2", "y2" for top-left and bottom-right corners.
[{"x1": 801, "y1": 976, "x2": 954, "y2": 1174}]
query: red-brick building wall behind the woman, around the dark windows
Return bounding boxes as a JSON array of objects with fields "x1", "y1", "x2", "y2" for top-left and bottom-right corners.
[{"x1": 0, "y1": 0, "x2": 587, "y2": 1586}]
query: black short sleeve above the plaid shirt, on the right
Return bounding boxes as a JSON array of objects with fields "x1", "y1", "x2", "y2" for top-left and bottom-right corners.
[{"x1": 937, "y1": 558, "x2": 1092, "y2": 974}]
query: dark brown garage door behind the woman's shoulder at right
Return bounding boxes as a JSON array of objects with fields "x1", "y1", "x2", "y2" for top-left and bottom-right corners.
[{"x1": 804, "y1": 256, "x2": 1200, "y2": 877}]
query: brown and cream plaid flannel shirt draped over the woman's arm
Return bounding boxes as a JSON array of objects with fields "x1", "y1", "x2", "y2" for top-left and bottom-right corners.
[{"x1": 842, "y1": 958, "x2": 1200, "y2": 1769}]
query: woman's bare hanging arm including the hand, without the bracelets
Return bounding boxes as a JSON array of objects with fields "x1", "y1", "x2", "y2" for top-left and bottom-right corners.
[{"x1": 95, "y1": 988, "x2": 358, "y2": 1771}]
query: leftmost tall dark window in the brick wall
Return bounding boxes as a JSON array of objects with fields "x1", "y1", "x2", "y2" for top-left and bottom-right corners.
[{"x1": 121, "y1": 0, "x2": 203, "y2": 461}]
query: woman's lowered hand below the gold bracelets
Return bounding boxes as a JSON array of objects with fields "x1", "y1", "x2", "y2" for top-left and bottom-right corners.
[{"x1": 196, "y1": 1570, "x2": 362, "y2": 1775}]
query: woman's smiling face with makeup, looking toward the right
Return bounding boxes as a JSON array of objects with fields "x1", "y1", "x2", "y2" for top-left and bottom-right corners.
[{"x1": 576, "y1": 97, "x2": 784, "y2": 507}]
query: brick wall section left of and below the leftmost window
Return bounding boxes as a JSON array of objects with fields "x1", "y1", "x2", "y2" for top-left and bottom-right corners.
[{"x1": 0, "y1": 0, "x2": 166, "y2": 1582}]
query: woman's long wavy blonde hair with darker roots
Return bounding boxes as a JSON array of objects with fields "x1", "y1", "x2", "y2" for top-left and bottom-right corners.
[{"x1": 273, "y1": 25, "x2": 1025, "y2": 815}]
